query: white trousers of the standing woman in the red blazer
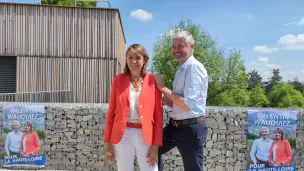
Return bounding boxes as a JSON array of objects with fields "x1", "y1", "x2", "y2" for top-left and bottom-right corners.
[{"x1": 114, "y1": 127, "x2": 158, "y2": 171}]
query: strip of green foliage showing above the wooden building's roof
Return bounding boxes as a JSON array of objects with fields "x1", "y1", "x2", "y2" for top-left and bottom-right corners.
[{"x1": 40, "y1": 0, "x2": 97, "y2": 7}]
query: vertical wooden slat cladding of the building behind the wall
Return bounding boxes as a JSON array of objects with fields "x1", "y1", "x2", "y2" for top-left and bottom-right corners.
[{"x1": 0, "y1": 3, "x2": 125, "y2": 103}]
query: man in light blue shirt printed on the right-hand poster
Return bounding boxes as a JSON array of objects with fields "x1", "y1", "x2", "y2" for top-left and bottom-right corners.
[{"x1": 250, "y1": 126, "x2": 272, "y2": 166}]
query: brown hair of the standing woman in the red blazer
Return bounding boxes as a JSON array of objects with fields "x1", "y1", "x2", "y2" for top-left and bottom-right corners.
[{"x1": 124, "y1": 44, "x2": 149, "y2": 77}]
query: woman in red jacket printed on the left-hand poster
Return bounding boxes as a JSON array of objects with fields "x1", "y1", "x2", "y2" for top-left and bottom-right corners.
[{"x1": 20, "y1": 121, "x2": 40, "y2": 157}]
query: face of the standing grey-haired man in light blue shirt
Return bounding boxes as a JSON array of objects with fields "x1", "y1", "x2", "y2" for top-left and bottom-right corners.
[{"x1": 173, "y1": 38, "x2": 194, "y2": 64}]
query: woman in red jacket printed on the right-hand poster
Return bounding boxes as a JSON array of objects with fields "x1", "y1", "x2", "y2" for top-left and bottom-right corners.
[{"x1": 269, "y1": 128, "x2": 292, "y2": 166}]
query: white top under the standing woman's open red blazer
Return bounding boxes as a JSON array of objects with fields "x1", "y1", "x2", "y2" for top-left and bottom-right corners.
[{"x1": 128, "y1": 83, "x2": 141, "y2": 123}]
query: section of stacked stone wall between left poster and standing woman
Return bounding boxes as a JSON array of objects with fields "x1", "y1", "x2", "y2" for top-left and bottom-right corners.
[{"x1": 45, "y1": 105, "x2": 107, "y2": 170}]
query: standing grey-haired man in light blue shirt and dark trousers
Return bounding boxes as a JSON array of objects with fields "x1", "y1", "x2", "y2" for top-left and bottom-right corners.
[{"x1": 155, "y1": 31, "x2": 208, "y2": 171}]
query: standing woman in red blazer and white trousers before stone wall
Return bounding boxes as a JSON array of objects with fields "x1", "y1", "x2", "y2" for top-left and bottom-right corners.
[{"x1": 104, "y1": 44, "x2": 163, "y2": 171}]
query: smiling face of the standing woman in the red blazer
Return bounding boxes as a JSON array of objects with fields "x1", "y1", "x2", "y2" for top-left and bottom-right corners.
[{"x1": 127, "y1": 52, "x2": 144, "y2": 73}]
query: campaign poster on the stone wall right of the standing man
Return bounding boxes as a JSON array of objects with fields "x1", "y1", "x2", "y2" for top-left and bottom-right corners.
[{"x1": 247, "y1": 110, "x2": 297, "y2": 171}]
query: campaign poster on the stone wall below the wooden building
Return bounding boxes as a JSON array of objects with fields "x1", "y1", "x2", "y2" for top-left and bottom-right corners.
[{"x1": 2, "y1": 105, "x2": 45, "y2": 167}]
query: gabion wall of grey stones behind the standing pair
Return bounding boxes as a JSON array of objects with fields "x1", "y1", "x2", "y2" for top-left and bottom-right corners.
[{"x1": 0, "y1": 103, "x2": 304, "y2": 171}]
